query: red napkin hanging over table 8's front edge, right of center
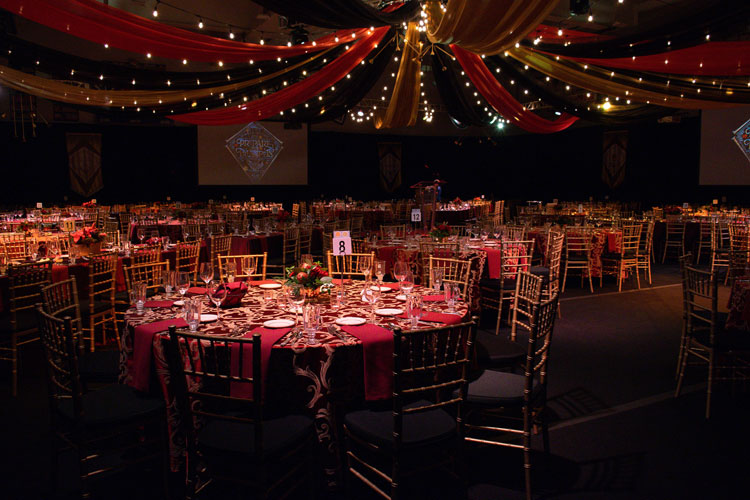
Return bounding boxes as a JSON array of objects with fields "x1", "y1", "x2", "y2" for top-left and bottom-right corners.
[{"x1": 342, "y1": 325, "x2": 393, "y2": 401}]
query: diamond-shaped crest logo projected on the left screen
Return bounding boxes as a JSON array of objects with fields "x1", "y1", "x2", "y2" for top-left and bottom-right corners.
[{"x1": 226, "y1": 123, "x2": 284, "y2": 182}]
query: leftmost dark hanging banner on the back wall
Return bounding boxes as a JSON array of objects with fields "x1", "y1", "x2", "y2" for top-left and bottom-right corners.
[{"x1": 65, "y1": 134, "x2": 104, "y2": 197}]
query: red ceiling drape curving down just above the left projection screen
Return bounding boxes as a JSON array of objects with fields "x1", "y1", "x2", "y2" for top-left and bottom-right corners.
[{"x1": 170, "y1": 26, "x2": 390, "y2": 125}]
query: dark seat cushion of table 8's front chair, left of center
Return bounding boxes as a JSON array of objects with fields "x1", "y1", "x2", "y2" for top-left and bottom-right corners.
[{"x1": 198, "y1": 415, "x2": 313, "y2": 456}]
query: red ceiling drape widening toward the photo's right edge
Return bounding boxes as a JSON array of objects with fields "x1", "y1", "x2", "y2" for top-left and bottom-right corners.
[{"x1": 551, "y1": 42, "x2": 750, "y2": 76}]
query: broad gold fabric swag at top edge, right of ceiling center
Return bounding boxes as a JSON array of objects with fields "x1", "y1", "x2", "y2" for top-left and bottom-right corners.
[{"x1": 425, "y1": 0, "x2": 557, "y2": 55}]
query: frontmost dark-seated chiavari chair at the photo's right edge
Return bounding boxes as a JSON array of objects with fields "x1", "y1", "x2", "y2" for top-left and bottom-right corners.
[{"x1": 675, "y1": 265, "x2": 750, "y2": 419}]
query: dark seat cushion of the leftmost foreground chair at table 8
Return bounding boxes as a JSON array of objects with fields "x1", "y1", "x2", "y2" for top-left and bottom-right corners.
[{"x1": 57, "y1": 384, "x2": 164, "y2": 426}]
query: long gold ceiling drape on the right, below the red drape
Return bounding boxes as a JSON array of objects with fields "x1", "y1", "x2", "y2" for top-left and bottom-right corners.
[{"x1": 507, "y1": 47, "x2": 741, "y2": 109}]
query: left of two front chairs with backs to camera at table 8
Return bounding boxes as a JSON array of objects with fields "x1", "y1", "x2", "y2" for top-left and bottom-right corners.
[{"x1": 167, "y1": 326, "x2": 314, "y2": 499}]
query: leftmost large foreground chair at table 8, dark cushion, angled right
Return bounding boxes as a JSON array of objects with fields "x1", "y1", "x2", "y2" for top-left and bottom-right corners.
[{"x1": 36, "y1": 307, "x2": 167, "y2": 498}]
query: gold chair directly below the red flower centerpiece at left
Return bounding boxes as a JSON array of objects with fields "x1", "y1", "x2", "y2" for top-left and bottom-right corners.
[{"x1": 83, "y1": 253, "x2": 120, "y2": 352}]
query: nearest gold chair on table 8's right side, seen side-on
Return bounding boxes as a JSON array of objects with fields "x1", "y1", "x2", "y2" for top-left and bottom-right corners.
[{"x1": 462, "y1": 296, "x2": 558, "y2": 500}]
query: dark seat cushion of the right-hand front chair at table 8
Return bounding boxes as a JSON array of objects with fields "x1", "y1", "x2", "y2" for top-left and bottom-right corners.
[{"x1": 344, "y1": 400, "x2": 457, "y2": 448}]
